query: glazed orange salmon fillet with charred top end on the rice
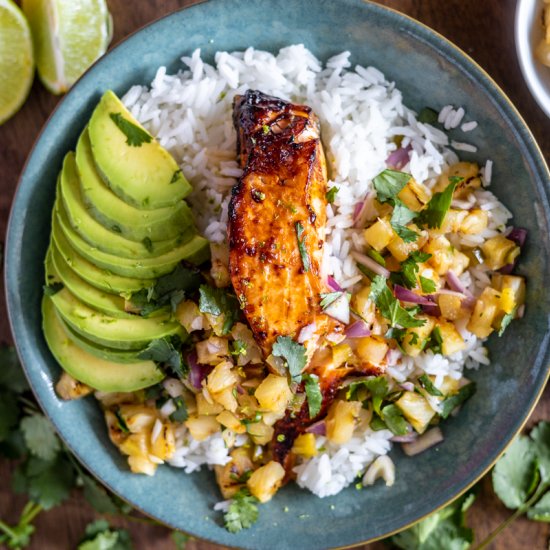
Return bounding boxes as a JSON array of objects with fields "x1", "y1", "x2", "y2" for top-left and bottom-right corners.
[{"x1": 229, "y1": 90, "x2": 343, "y2": 356}]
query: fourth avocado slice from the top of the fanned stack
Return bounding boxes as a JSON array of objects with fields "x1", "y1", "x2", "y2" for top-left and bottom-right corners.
[{"x1": 53, "y1": 197, "x2": 210, "y2": 279}]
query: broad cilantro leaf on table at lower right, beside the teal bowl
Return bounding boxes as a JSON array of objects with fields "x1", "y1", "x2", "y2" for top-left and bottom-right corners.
[{"x1": 493, "y1": 435, "x2": 538, "y2": 509}]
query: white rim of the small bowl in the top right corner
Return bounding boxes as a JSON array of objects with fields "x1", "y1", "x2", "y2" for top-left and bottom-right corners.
[{"x1": 514, "y1": 0, "x2": 550, "y2": 118}]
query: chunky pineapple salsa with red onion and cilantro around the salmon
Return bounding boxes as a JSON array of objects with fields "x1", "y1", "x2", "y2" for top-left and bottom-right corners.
[{"x1": 58, "y1": 158, "x2": 525, "y2": 530}]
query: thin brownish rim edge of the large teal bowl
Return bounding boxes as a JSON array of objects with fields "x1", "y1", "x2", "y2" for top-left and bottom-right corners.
[{"x1": 3, "y1": 0, "x2": 550, "y2": 550}]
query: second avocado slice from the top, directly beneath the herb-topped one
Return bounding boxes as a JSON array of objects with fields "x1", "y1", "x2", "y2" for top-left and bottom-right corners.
[{"x1": 76, "y1": 128, "x2": 193, "y2": 242}]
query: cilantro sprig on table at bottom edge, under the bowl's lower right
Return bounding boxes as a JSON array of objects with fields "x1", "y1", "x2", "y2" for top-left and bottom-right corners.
[{"x1": 390, "y1": 492, "x2": 475, "y2": 550}]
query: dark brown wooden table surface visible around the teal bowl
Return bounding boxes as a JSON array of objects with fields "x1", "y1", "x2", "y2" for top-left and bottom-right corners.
[{"x1": 0, "y1": 0, "x2": 550, "y2": 550}]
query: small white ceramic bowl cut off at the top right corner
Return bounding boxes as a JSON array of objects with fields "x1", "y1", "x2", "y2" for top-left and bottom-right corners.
[{"x1": 515, "y1": 0, "x2": 550, "y2": 117}]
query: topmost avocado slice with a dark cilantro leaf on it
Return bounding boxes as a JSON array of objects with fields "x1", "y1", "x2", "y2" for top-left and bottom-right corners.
[{"x1": 88, "y1": 90, "x2": 191, "y2": 210}]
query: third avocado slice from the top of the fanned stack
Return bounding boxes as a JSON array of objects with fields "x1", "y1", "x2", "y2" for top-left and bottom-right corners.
[{"x1": 59, "y1": 151, "x2": 192, "y2": 259}]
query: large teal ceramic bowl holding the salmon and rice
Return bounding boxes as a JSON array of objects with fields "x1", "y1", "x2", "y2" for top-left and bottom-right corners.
[{"x1": 6, "y1": 0, "x2": 550, "y2": 550}]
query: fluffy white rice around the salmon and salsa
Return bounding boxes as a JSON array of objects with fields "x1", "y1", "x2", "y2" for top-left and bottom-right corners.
[{"x1": 123, "y1": 45, "x2": 511, "y2": 497}]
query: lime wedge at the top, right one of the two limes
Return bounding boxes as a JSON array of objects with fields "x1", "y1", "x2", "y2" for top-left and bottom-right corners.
[{"x1": 22, "y1": 0, "x2": 111, "y2": 94}]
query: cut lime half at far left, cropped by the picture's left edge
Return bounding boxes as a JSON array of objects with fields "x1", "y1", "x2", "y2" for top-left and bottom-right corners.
[{"x1": 0, "y1": 0, "x2": 34, "y2": 124}]
